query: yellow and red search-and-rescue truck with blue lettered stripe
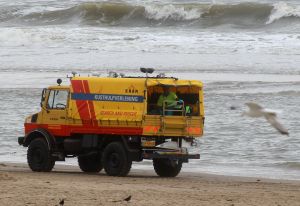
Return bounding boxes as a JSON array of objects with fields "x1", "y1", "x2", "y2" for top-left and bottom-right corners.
[{"x1": 18, "y1": 68, "x2": 204, "y2": 177}]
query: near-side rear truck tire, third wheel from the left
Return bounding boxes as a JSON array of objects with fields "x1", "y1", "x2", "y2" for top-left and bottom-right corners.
[{"x1": 102, "y1": 142, "x2": 132, "y2": 176}]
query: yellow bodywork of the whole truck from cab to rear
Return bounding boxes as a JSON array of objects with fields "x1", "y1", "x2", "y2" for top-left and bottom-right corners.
[{"x1": 38, "y1": 77, "x2": 204, "y2": 137}]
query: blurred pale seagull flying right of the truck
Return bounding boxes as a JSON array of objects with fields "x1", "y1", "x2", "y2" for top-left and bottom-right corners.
[{"x1": 243, "y1": 102, "x2": 289, "y2": 136}]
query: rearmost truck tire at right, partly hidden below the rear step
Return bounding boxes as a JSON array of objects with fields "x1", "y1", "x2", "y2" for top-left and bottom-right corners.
[{"x1": 153, "y1": 159, "x2": 182, "y2": 177}]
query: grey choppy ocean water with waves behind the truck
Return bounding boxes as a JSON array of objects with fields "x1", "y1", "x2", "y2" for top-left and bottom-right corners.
[{"x1": 0, "y1": 0, "x2": 300, "y2": 180}]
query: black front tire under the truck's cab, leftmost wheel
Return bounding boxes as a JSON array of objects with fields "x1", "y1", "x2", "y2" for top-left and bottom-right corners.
[{"x1": 27, "y1": 138, "x2": 55, "y2": 172}]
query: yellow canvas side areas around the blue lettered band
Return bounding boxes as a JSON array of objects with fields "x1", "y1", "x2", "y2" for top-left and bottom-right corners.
[{"x1": 68, "y1": 77, "x2": 145, "y2": 121}]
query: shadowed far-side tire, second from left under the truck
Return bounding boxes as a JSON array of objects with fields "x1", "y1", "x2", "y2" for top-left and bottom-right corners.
[{"x1": 78, "y1": 153, "x2": 103, "y2": 172}]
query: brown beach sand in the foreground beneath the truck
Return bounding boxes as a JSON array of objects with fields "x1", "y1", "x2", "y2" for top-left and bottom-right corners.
[{"x1": 0, "y1": 163, "x2": 300, "y2": 206}]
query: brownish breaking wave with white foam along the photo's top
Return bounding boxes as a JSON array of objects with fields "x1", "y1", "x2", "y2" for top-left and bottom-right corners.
[{"x1": 0, "y1": 2, "x2": 300, "y2": 27}]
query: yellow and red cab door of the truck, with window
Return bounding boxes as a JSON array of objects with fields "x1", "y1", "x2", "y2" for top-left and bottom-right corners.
[{"x1": 43, "y1": 89, "x2": 69, "y2": 136}]
